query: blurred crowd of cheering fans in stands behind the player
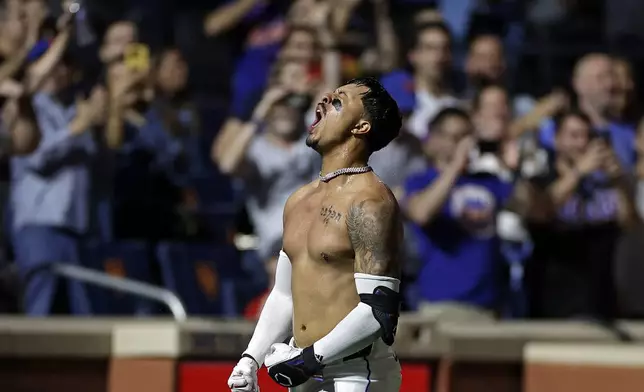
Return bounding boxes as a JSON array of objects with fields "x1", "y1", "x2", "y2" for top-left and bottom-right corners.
[{"x1": 0, "y1": 0, "x2": 644, "y2": 320}]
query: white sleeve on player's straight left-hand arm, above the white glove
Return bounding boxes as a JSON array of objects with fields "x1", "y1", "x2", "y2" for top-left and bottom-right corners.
[{"x1": 244, "y1": 251, "x2": 293, "y2": 367}]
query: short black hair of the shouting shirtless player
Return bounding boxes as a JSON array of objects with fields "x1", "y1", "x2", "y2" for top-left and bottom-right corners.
[{"x1": 347, "y1": 77, "x2": 402, "y2": 152}]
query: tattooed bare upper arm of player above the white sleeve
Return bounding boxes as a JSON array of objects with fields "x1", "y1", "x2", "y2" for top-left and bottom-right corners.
[{"x1": 346, "y1": 200, "x2": 400, "y2": 277}]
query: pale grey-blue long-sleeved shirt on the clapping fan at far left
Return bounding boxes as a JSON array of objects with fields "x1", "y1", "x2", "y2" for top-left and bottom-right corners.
[{"x1": 11, "y1": 93, "x2": 101, "y2": 234}]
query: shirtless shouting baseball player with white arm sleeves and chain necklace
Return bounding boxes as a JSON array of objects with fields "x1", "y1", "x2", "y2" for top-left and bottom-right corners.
[{"x1": 228, "y1": 78, "x2": 402, "y2": 392}]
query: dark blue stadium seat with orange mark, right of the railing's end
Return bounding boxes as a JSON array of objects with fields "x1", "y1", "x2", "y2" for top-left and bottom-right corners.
[{"x1": 156, "y1": 242, "x2": 241, "y2": 317}]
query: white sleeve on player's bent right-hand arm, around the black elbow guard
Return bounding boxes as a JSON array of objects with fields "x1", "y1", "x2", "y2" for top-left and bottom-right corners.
[{"x1": 313, "y1": 273, "x2": 400, "y2": 364}]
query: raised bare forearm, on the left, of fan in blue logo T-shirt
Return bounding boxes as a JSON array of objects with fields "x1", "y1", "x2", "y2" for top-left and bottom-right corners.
[{"x1": 406, "y1": 168, "x2": 458, "y2": 226}]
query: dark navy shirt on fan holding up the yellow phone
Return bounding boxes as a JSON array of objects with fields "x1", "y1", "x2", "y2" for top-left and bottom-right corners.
[{"x1": 112, "y1": 105, "x2": 190, "y2": 238}]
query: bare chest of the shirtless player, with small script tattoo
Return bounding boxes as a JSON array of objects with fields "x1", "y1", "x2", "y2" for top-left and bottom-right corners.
[{"x1": 284, "y1": 196, "x2": 354, "y2": 263}]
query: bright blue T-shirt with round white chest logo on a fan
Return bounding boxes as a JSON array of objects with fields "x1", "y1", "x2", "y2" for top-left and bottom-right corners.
[{"x1": 405, "y1": 168, "x2": 512, "y2": 308}]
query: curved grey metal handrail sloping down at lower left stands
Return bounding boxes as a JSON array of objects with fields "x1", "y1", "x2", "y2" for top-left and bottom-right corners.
[{"x1": 24, "y1": 263, "x2": 188, "y2": 321}]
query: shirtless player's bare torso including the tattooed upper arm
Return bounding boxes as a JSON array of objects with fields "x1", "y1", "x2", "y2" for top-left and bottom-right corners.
[{"x1": 283, "y1": 174, "x2": 402, "y2": 347}]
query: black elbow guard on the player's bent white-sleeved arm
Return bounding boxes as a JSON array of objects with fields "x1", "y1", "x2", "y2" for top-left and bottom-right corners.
[{"x1": 360, "y1": 286, "x2": 401, "y2": 346}]
